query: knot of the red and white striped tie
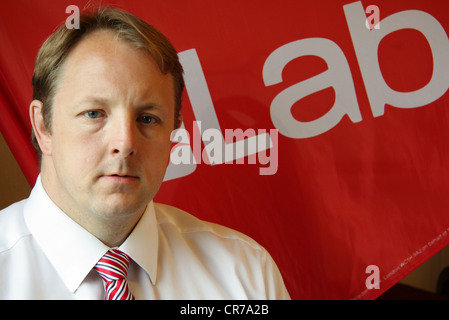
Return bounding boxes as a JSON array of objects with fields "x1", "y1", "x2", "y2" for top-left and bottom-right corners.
[{"x1": 95, "y1": 249, "x2": 129, "y2": 281}]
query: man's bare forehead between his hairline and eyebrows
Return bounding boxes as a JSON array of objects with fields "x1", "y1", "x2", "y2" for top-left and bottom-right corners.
[{"x1": 56, "y1": 30, "x2": 174, "y2": 108}]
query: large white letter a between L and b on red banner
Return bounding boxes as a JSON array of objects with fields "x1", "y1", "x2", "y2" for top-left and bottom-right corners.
[{"x1": 262, "y1": 38, "x2": 362, "y2": 139}]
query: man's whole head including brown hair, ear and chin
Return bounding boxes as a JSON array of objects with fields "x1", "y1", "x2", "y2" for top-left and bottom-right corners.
[{"x1": 30, "y1": 9, "x2": 184, "y2": 240}]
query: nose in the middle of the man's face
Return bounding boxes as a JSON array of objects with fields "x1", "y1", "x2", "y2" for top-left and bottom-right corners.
[{"x1": 109, "y1": 117, "x2": 137, "y2": 158}]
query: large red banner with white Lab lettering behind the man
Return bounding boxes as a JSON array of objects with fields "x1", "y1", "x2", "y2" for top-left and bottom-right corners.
[{"x1": 0, "y1": 0, "x2": 449, "y2": 299}]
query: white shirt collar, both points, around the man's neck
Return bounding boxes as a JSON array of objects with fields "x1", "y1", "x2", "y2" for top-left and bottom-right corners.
[{"x1": 24, "y1": 175, "x2": 158, "y2": 292}]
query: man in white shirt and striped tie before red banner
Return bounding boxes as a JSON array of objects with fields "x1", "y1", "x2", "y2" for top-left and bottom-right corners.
[{"x1": 0, "y1": 8, "x2": 289, "y2": 299}]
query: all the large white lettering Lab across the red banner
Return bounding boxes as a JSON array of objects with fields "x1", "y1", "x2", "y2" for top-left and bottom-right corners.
[{"x1": 164, "y1": 1, "x2": 449, "y2": 180}]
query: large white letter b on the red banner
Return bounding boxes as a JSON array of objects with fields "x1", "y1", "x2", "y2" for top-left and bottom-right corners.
[{"x1": 343, "y1": 2, "x2": 449, "y2": 117}]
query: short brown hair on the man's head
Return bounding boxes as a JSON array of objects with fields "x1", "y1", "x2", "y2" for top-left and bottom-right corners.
[{"x1": 31, "y1": 7, "x2": 184, "y2": 159}]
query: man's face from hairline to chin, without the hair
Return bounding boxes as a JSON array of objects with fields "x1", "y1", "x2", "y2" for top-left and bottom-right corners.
[{"x1": 39, "y1": 31, "x2": 174, "y2": 222}]
